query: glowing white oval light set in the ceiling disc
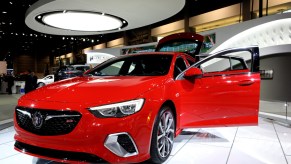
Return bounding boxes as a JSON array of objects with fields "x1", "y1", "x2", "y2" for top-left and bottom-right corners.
[{"x1": 35, "y1": 10, "x2": 128, "y2": 32}]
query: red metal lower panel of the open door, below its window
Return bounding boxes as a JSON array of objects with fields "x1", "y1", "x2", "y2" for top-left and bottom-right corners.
[{"x1": 177, "y1": 74, "x2": 260, "y2": 128}]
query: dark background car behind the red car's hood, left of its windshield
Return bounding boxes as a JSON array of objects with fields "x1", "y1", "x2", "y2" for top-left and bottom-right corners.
[{"x1": 54, "y1": 65, "x2": 90, "y2": 81}]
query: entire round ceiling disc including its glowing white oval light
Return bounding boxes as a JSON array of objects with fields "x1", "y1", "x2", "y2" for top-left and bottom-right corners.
[{"x1": 25, "y1": 0, "x2": 185, "y2": 35}]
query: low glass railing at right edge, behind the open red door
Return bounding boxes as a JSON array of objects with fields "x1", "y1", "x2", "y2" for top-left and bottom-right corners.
[{"x1": 259, "y1": 100, "x2": 291, "y2": 126}]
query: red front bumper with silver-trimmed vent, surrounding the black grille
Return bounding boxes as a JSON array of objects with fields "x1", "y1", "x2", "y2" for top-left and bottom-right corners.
[{"x1": 14, "y1": 98, "x2": 154, "y2": 163}]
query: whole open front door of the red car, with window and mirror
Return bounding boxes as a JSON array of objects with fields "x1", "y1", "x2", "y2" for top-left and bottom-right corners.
[{"x1": 175, "y1": 46, "x2": 260, "y2": 128}]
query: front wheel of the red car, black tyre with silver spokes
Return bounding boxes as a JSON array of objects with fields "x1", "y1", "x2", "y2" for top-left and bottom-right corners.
[{"x1": 150, "y1": 106, "x2": 175, "y2": 163}]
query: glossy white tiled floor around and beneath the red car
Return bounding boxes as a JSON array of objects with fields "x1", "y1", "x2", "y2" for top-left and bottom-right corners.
[{"x1": 0, "y1": 118, "x2": 291, "y2": 164}]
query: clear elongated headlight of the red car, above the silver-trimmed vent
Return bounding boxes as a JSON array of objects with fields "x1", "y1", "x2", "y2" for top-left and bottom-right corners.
[{"x1": 89, "y1": 99, "x2": 144, "y2": 117}]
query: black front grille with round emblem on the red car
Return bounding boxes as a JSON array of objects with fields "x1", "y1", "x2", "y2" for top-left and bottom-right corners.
[{"x1": 15, "y1": 107, "x2": 81, "y2": 136}]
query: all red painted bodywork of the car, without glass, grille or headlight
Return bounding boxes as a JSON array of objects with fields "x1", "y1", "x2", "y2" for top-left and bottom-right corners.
[{"x1": 14, "y1": 32, "x2": 260, "y2": 163}]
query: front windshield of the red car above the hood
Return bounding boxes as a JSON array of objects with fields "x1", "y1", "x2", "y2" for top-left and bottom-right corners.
[{"x1": 86, "y1": 54, "x2": 173, "y2": 76}]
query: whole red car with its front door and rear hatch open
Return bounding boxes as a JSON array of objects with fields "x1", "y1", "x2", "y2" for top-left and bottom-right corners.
[{"x1": 14, "y1": 33, "x2": 260, "y2": 163}]
